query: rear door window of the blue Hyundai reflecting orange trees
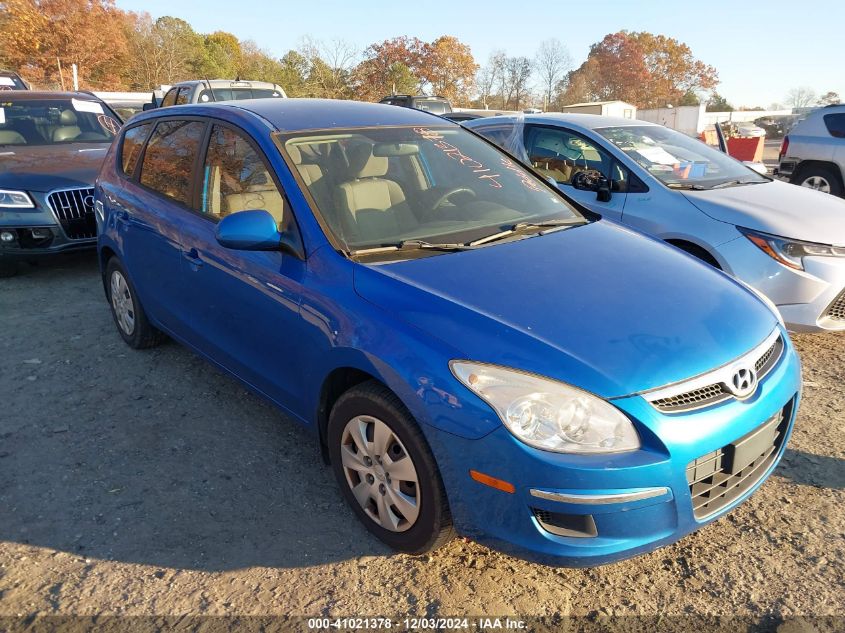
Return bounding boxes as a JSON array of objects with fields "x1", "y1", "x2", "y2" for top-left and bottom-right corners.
[{"x1": 141, "y1": 121, "x2": 205, "y2": 206}]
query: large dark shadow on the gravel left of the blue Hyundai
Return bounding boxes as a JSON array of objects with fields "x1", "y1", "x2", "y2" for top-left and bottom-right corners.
[{"x1": 0, "y1": 257, "x2": 392, "y2": 571}]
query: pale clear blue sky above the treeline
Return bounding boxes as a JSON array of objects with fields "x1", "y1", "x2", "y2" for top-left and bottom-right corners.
[{"x1": 117, "y1": 0, "x2": 845, "y2": 107}]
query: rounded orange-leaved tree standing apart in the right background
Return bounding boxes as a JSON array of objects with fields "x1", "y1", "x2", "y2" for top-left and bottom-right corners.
[{"x1": 563, "y1": 31, "x2": 718, "y2": 108}]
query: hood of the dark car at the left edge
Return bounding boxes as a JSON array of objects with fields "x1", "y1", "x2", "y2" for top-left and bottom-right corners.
[{"x1": 0, "y1": 143, "x2": 109, "y2": 192}]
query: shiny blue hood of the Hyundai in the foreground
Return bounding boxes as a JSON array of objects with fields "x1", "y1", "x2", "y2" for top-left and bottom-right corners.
[{"x1": 354, "y1": 222, "x2": 777, "y2": 398}]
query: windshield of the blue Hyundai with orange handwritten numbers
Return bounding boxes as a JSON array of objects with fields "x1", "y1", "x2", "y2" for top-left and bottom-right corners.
[{"x1": 284, "y1": 126, "x2": 584, "y2": 251}]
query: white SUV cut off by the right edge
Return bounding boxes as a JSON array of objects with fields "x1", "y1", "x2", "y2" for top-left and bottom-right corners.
[{"x1": 775, "y1": 105, "x2": 845, "y2": 196}]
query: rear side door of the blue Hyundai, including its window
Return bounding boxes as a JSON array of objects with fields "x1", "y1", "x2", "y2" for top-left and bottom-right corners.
[{"x1": 117, "y1": 119, "x2": 206, "y2": 338}]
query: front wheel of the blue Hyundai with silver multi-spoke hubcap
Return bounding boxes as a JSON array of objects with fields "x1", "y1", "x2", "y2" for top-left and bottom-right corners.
[{"x1": 327, "y1": 380, "x2": 453, "y2": 554}]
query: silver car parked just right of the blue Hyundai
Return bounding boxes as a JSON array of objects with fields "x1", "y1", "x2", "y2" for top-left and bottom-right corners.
[{"x1": 463, "y1": 114, "x2": 845, "y2": 331}]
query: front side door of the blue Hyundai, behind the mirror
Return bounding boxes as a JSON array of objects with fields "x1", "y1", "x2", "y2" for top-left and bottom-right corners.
[{"x1": 182, "y1": 122, "x2": 308, "y2": 410}]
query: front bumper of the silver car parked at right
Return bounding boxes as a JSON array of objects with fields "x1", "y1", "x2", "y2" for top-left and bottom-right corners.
[{"x1": 719, "y1": 237, "x2": 845, "y2": 332}]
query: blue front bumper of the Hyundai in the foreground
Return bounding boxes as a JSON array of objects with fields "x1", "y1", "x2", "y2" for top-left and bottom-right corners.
[{"x1": 426, "y1": 336, "x2": 801, "y2": 567}]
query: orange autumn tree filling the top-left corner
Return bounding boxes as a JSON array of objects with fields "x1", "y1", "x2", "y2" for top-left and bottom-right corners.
[{"x1": 0, "y1": 0, "x2": 127, "y2": 89}]
